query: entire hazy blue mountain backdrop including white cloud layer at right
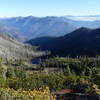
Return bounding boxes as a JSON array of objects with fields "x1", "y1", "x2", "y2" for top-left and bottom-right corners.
[{"x1": 0, "y1": 15, "x2": 100, "y2": 41}]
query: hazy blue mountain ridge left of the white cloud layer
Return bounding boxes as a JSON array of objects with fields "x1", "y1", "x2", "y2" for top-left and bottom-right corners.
[{"x1": 0, "y1": 16, "x2": 76, "y2": 41}]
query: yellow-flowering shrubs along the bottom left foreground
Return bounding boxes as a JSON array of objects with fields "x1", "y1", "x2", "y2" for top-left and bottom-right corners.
[{"x1": 0, "y1": 87, "x2": 56, "y2": 100}]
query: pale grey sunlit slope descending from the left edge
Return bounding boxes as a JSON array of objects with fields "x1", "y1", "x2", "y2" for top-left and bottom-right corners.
[{"x1": 0, "y1": 34, "x2": 44, "y2": 60}]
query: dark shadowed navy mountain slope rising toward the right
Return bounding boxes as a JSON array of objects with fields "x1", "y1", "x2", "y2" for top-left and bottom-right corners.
[{"x1": 28, "y1": 28, "x2": 100, "y2": 56}]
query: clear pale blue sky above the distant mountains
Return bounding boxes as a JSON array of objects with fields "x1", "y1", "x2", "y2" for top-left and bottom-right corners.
[{"x1": 0, "y1": 0, "x2": 100, "y2": 17}]
